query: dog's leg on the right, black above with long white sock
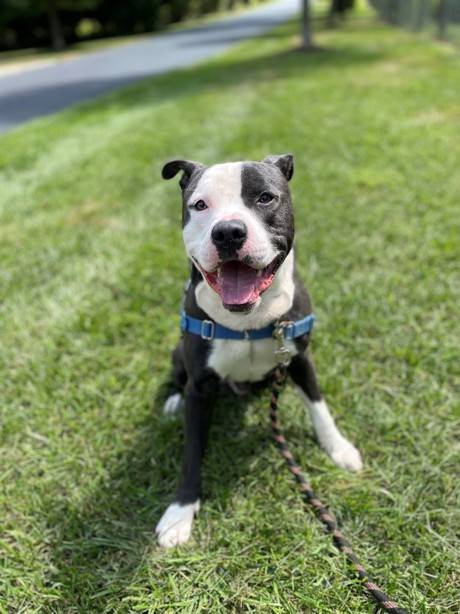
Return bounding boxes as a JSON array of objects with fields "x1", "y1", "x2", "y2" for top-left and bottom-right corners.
[{"x1": 289, "y1": 354, "x2": 363, "y2": 471}]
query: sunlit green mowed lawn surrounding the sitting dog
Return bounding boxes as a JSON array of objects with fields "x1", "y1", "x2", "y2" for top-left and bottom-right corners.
[{"x1": 0, "y1": 14, "x2": 460, "y2": 614}]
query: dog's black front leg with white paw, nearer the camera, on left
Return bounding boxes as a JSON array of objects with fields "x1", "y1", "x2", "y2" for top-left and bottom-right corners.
[{"x1": 155, "y1": 374, "x2": 218, "y2": 548}]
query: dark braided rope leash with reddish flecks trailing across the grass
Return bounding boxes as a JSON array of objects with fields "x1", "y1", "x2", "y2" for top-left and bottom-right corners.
[{"x1": 270, "y1": 365, "x2": 407, "y2": 614}]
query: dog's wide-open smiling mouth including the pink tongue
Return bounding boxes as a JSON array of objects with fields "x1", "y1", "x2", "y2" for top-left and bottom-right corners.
[{"x1": 197, "y1": 256, "x2": 281, "y2": 311}]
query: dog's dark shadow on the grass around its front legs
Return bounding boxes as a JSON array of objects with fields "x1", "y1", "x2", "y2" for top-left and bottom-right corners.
[{"x1": 48, "y1": 376, "x2": 286, "y2": 612}]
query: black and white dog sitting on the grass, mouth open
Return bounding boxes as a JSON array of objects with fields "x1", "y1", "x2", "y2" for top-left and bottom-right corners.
[{"x1": 156, "y1": 155, "x2": 362, "y2": 547}]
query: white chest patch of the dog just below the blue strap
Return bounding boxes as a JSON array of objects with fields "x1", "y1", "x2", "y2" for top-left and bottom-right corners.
[{"x1": 208, "y1": 339, "x2": 296, "y2": 382}]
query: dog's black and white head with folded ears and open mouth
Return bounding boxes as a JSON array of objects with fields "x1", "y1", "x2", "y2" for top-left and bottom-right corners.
[{"x1": 163, "y1": 154, "x2": 294, "y2": 312}]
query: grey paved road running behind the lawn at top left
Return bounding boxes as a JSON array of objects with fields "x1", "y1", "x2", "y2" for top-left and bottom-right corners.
[{"x1": 0, "y1": 0, "x2": 299, "y2": 132}]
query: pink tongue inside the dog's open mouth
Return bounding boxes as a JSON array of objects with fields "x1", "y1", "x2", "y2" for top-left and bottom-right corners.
[{"x1": 219, "y1": 261, "x2": 258, "y2": 305}]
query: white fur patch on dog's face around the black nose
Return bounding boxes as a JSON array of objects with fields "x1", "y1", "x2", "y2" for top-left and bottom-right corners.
[{"x1": 183, "y1": 162, "x2": 277, "y2": 272}]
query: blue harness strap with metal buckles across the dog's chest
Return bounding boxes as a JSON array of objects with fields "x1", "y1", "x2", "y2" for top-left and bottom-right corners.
[{"x1": 180, "y1": 311, "x2": 315, "y2": 341}]
